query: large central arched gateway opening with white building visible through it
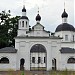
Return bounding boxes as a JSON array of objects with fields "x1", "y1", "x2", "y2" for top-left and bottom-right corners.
[{"x1": 30, "y1": 44, "x2": 47, "y2": 70}]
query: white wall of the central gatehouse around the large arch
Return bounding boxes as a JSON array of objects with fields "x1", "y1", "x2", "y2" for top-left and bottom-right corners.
[{"x1": 15, "y1": 38, "x2": 61, "y2": 70}]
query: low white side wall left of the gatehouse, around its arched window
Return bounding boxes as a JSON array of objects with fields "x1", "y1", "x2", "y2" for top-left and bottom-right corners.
[{"x1": 0, "y1": 53, "x2": 17, "y2": 71}]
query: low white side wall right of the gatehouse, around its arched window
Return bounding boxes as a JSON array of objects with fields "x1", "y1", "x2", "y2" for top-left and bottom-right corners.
[{"x1": 59, "y1": 53, "x2": 75, "y2": 70}]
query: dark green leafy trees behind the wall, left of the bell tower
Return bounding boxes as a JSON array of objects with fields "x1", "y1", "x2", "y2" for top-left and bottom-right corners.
[{"x1": 0, "y1": 10, "x2": 20, "y2": 48}]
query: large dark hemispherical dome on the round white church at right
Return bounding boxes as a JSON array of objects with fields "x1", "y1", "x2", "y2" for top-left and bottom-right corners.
[{"x1": 55, "y1": 23, "x2": 75, "y2": 32}]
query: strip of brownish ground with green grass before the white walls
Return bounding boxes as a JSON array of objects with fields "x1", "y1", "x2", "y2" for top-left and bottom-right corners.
[{"x1": 0, "y1": 71, "x2": 75, "y2": 75}]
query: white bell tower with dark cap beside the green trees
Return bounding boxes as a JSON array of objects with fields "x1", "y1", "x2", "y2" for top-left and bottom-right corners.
[{"x1": 17, "y1": 5, "x2": 29, "y2": 36}]
